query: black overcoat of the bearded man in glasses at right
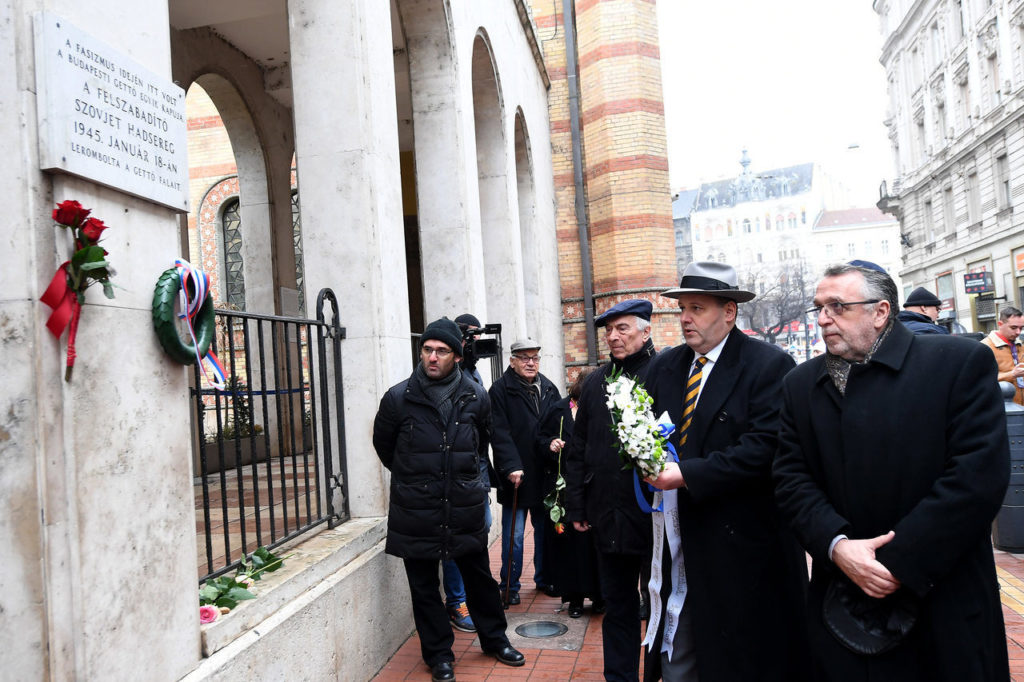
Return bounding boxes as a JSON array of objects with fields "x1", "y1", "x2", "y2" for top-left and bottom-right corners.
[{"x1": 774, "y1": 324, "x2": 1010, "y2": 682}]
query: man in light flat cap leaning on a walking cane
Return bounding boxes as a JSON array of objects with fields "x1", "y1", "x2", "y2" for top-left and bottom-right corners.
[{"x1": 487, "y1": 339, "x2": 561, "y2": 605}]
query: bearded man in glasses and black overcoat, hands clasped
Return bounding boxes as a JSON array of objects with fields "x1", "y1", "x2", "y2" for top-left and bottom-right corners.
[{"x1": 773, "y1": 265, "x2": 1010, "y2": 682}]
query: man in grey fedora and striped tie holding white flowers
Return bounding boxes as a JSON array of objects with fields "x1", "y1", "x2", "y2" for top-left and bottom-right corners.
[{"x1": 644, "y1": 262, "x2": 808, "y2": 682}]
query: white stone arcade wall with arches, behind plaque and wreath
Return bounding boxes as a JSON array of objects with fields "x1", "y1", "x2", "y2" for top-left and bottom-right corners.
[{"x1": 0, "y1": 0, "x2": 562, "y2": 680}]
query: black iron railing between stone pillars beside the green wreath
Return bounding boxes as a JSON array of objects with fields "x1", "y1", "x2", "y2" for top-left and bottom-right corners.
[{"x1": 191, "y1": 289, "x2": 348, "y2": 583}]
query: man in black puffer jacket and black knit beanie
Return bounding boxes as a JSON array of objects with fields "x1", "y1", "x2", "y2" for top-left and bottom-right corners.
[{"x1": 374, "y1": 317, "x2": 525, "y2": 681}]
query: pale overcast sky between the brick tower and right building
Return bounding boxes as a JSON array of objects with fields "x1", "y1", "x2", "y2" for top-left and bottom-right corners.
[{"x1": 657, "y1": 0, "x2": 893, "y2": 206}]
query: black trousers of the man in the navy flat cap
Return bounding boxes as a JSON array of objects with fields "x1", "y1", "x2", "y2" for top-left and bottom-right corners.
[{"x1": 597, "y1": 551, "x2": 650, "y2": 682}]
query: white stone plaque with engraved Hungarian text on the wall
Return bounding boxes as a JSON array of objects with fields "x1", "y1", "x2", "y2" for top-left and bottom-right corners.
[{"x1": 35, "y1": 12, "x2": 188, "y2": 212}]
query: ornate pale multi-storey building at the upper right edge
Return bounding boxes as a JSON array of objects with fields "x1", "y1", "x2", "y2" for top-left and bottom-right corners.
[{"x1": 873, "y1": 0, "x2": 1024, "y2": 332}]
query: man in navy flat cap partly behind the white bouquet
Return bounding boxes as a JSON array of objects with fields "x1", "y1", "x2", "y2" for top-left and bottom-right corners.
[{"x1": 565, "y1": 299, "x2": 654, "y2": 680}]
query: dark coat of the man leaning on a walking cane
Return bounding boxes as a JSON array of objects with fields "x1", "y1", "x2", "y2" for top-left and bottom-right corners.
[{"x1": 487, "y1": 368, "x2": 560, "y2": 509}]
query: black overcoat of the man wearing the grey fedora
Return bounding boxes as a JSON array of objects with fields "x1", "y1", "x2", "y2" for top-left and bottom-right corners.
[{"x1": 644, "y1": 329, "x2": 809, "y2": 682}]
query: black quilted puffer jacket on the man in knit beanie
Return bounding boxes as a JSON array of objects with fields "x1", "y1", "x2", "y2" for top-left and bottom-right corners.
[{"x1": 373, "y1": 374, "x2": 519, "y2": 559}]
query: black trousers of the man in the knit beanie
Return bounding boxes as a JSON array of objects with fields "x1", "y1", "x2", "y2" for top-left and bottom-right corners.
[{"x1": 404, "y1": 549, "x2": 509, "y2": 668}]
